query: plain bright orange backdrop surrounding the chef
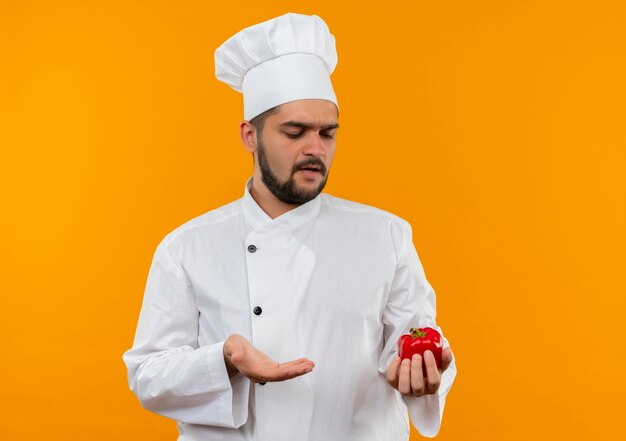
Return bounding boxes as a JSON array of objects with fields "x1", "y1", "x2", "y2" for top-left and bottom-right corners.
[{"x1": 0, "y1": 0, "x2": 626, "y2": 441}]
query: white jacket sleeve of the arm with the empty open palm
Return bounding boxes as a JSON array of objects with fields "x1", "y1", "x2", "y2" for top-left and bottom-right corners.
[{"x1": 123, "y1": 237, "x2": 250, "y2": 428}]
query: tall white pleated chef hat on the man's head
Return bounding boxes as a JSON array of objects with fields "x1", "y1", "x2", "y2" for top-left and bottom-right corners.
[{"x1": 215, "y1": 13, "x2": 337, "y2": 120}]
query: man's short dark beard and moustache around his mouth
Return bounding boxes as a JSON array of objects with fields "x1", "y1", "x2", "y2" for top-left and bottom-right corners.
[{"x1": 257, "y1": 137, "x2": 328, "y2": 205}]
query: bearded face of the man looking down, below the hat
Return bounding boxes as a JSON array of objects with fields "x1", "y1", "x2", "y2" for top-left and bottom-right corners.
[{"x1": 252, "y1": 100, "x2": 339, "y2": 204}]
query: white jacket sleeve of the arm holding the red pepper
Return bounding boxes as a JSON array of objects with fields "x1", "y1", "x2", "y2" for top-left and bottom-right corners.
[{"x1": 379, "y1": 221, "x2": 456, "y2": 437}]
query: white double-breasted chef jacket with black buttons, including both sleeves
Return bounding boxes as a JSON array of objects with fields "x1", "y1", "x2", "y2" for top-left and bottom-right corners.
[{"x1": 123, "y1": 178, "x2": 456, "y2": 441}]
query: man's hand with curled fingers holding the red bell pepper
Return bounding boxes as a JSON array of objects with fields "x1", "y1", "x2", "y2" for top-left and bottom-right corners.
[{"x1": 387, "y1": 348, "x2": 452, "y2": 397}]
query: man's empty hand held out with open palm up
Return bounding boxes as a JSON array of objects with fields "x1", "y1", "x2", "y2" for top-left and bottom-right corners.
[{"x1": 224, "y1": 334, "x2": 315, "y2": 383}]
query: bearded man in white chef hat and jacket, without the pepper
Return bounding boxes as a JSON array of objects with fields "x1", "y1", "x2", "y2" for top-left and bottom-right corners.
[{"x1": 123, "y1": 13, "x2": 456, "y2": 441}]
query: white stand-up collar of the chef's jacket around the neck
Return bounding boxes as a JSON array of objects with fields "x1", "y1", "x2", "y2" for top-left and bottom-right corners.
[{"x1": 241, "y1": 176, "x2": 322, "y2": 233}]
